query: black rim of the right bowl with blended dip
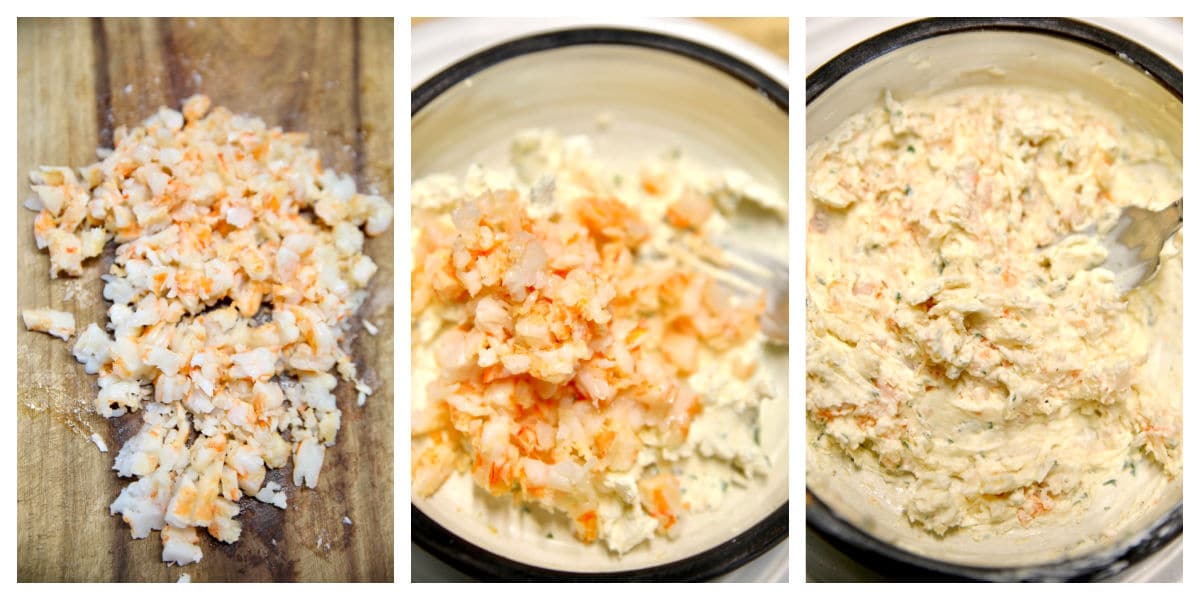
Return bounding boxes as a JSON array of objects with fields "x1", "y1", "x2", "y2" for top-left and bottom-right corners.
[{"x1": 804, "y1": 17, "x2": 1183, "y2": 581}]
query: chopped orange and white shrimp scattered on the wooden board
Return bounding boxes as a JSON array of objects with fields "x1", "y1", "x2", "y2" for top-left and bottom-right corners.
[{"x1": 24, "y1": 96, "x2": 392, "y2": 564}]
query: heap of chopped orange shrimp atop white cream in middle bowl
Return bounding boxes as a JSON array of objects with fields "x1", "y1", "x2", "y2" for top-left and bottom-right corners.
[{"x1": 412, "y1": 154, "x2": 764, "y2": 553}]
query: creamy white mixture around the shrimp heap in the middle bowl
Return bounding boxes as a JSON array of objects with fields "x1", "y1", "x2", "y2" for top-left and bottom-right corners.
[{"x1": 412, "y1": 131, "x2": 786, "y2": 554}]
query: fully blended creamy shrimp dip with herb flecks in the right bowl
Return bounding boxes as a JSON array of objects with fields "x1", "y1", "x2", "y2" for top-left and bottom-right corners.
[{"x1": 805, "y1": 88, "x2": 1183, "y2": 549}]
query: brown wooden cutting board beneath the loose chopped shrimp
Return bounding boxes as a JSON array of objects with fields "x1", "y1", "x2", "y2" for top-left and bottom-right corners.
[{"x1": 11, "y1": 19, "x2": 394, "y2": 581}]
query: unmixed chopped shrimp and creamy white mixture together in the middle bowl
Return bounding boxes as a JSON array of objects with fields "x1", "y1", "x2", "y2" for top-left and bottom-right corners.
[{"x1": 412, "y1": 131, "x2": 785, "y2": 556}]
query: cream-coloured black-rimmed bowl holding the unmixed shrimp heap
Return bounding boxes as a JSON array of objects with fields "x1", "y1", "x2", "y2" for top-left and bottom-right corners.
[{"x1": 412, "y1": 29, "x2": 788, "y2": 581}]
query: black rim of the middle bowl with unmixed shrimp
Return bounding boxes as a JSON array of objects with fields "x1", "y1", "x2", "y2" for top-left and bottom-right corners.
[{"x1": 410, "y1": 26, "x2": 790, "y2": 582}]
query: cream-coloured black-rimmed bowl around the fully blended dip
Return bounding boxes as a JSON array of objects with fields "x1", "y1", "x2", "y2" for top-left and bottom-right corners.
[{"x1": 805, "y1": 18, "x2": 1183, "y2": 581}]
